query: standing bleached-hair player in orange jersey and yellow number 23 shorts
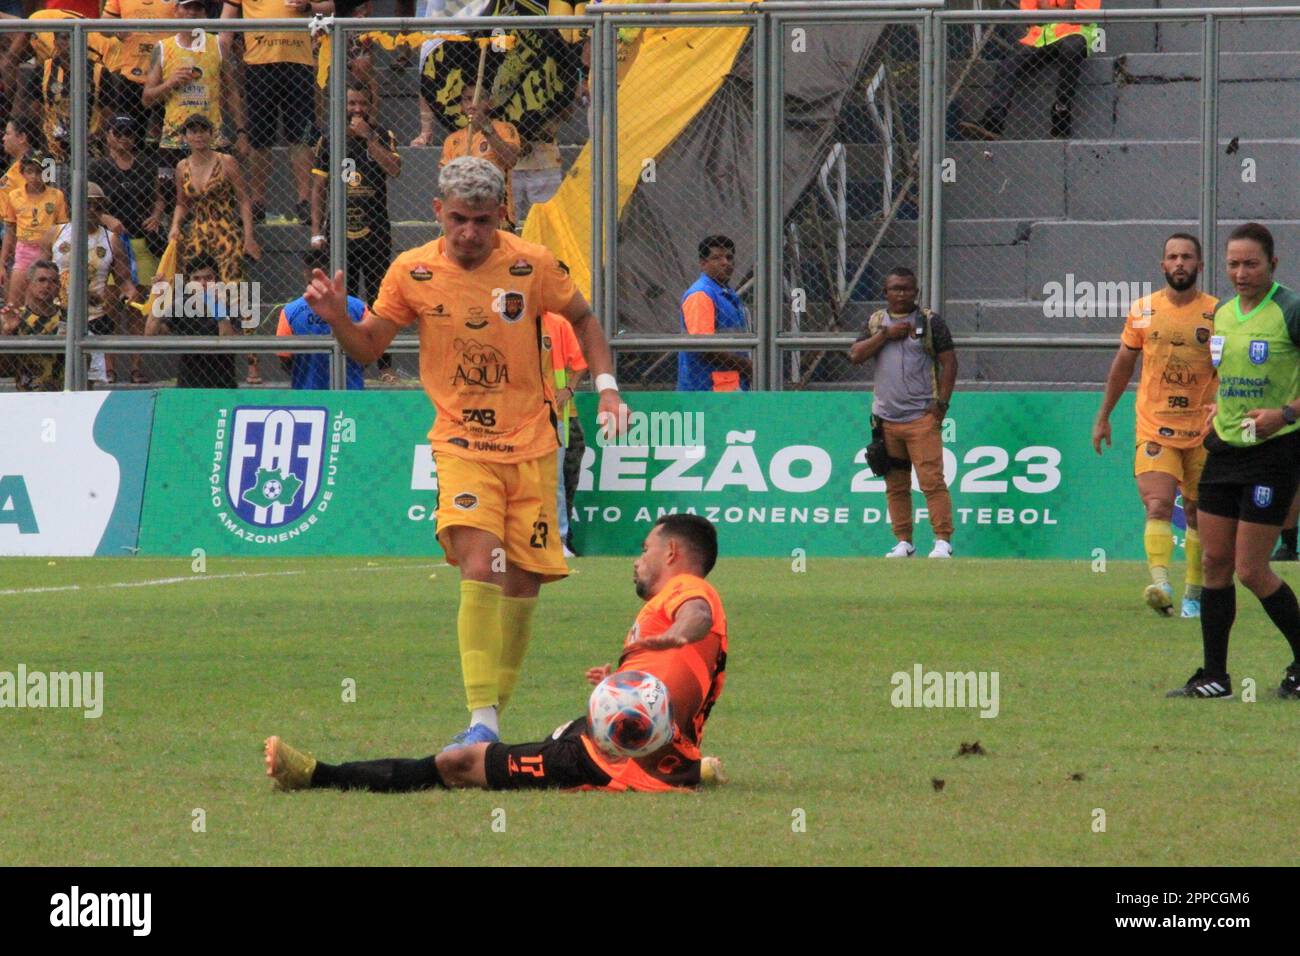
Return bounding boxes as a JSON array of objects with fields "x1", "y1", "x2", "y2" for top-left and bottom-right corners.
[{"x1": 306, "y1": 157, "x2": 627, "y2": 747}]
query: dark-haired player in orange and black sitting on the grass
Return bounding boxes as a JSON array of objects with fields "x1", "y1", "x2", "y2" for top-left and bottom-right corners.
[{"x1": 265, "y1": 515, "x2": 727, "y2": 793}]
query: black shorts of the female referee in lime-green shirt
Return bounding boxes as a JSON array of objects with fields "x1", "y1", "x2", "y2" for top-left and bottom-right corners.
[{"x1": 1196, "y1": 432, "x2": 1300, "y2": 525}]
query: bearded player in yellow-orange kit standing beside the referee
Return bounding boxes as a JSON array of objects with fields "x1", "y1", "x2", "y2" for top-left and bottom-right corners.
[{"x1": 1092, "y1": 233, "x2": 1218, "y2": 618}]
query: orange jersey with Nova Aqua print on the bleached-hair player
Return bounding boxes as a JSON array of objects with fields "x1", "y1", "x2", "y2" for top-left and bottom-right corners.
[{"x1": 372, "y1": 232, "x2": 575, "y2": 464}]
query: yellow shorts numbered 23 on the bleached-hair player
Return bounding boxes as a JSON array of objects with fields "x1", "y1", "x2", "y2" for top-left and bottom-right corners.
[{"x1": 433, "y1": 451, "x2": 569, "y2": 581}]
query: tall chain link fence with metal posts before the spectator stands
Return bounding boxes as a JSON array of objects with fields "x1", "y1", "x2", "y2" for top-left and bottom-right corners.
[{"x1": 0, "y1": 0, "x2": 1300, "y2": 390}]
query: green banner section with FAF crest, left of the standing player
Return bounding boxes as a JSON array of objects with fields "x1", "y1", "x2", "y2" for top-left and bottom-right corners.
[{"x1": 140, "y1": 390, "x2": 441, "y2": 555}]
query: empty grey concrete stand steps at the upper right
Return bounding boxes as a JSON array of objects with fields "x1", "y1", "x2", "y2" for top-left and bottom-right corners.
[{"x1": 935, "y1": 0, "x2": 1300, "y2": 388}]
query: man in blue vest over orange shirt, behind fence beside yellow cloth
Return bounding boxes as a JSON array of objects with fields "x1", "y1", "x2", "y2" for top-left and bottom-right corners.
[{"x1": 677, "y1": 235, "x2": 754, "y2": 392}]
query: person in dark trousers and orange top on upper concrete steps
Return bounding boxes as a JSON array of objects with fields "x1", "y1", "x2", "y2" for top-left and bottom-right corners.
[{"x1": 962, "y1": 0, "x2": 1101, "y2": 139}]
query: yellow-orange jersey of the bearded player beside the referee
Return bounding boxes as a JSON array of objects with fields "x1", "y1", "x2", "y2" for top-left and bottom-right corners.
[{"x1": 1119, "y1": 289, "x2": 1218, "y2": 449}]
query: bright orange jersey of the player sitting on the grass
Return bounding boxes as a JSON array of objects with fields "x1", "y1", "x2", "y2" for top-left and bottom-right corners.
[{"x1": 582, "y1": 575, "x2": 727, "y2": 791}]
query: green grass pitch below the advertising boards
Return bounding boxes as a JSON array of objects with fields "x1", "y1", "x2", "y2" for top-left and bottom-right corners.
[{"x1": 0, "y1": 555, "x2": 1300, "y2": 866}]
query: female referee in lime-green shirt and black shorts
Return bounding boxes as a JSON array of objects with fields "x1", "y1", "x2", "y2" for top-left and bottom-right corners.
[{"x1": 1167, "y1": 222, "x2": 1300, "y2": 698}]
